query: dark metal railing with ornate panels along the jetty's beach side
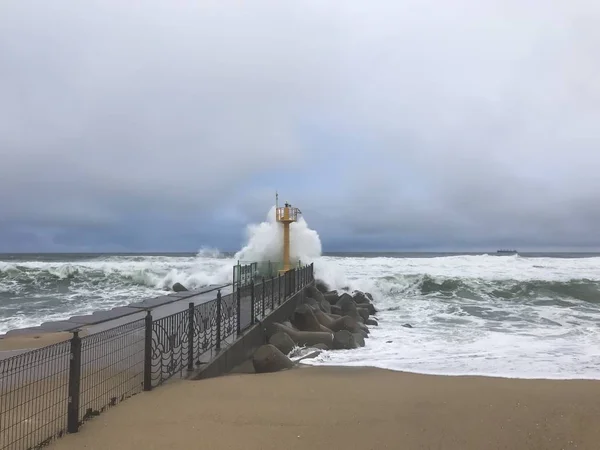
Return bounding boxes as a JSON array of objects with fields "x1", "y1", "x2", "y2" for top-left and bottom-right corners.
[{"x1": 0, "y1": 264, "x2": 314, "y2": 450}]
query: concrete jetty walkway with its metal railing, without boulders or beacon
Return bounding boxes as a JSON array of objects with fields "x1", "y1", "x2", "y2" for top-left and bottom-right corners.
[{"x1": 0, "y1": 264, "x2": 314, "y2": 450}]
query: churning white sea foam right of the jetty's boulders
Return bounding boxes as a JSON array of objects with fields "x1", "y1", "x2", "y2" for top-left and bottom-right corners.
[{"x1": 305, "y1": 256, "x2": 600, "y2": 379}]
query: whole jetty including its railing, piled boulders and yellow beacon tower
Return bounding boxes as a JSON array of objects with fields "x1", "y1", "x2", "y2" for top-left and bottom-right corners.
[{"x1": 0, "y1": 203, "x2": 377, "y2": 450}]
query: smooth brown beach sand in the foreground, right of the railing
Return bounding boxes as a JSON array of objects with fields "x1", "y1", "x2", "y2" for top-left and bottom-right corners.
[{"x1": 42, "y1": 367, "x2": 600, "y2": 450}]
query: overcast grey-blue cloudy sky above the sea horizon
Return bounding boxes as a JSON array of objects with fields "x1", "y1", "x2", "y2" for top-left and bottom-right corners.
[{"x1": 0, "y1": 0, "x2": 600, "y2": 252}]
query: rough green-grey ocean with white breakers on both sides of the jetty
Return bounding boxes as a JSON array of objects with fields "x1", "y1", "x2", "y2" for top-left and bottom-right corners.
[{"x1": 0, "y1": 250, "x2": 600, "y2": 379}]
